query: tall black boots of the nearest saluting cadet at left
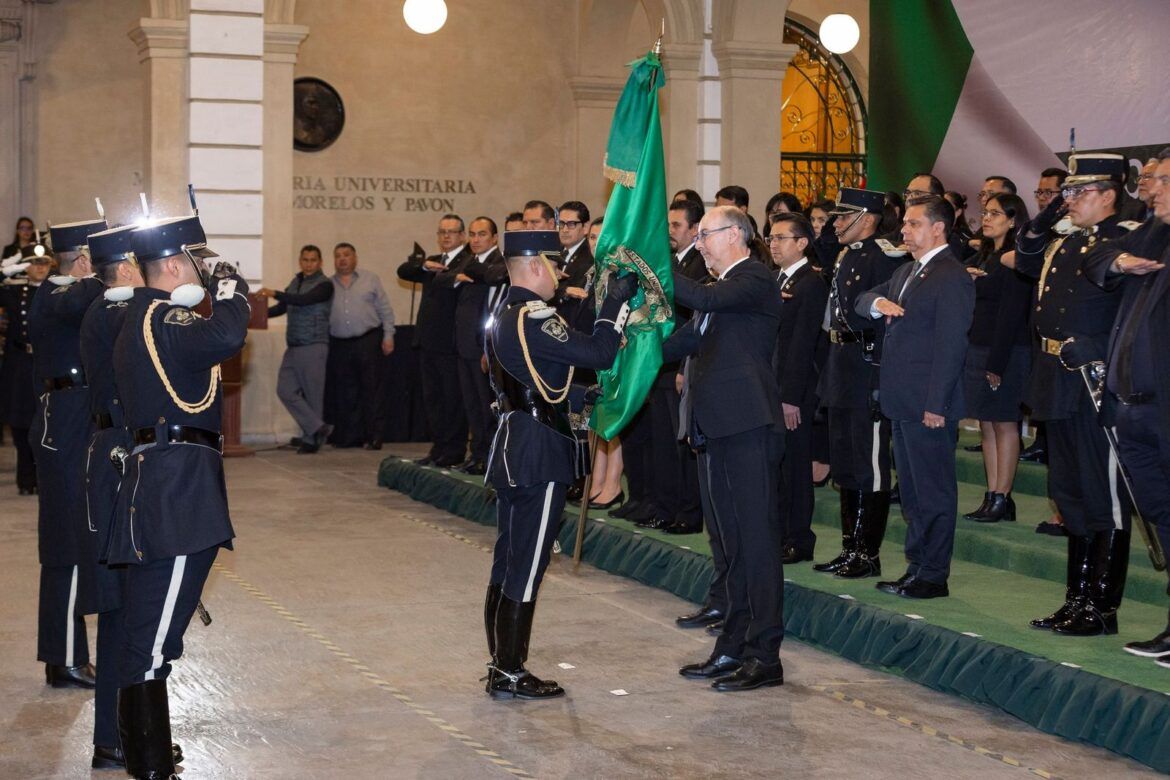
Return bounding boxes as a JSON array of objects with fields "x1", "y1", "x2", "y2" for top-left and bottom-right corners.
[{"x1": 118, "y1": 679, "x2": 174, "y2": 780}]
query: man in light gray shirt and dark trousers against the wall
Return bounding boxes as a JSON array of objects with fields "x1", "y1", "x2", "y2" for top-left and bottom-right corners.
[{"x1": 325, "y1": 242, "x2": 394, "y2": 449}]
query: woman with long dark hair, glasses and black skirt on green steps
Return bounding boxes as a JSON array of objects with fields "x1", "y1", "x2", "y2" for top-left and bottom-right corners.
[{"x1": 964, "y1": 193, "x2": 1032, "y2": 523}]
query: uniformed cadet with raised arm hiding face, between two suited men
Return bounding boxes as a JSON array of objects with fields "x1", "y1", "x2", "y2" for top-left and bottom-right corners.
[{"x1": 813, "y1": 187, "x2": 904, "y2": 579}]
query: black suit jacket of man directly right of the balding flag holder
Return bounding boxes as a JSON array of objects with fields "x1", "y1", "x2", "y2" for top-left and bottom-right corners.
[{"x1": 772, "y1": 262, "x2": 828, "y2": 407}]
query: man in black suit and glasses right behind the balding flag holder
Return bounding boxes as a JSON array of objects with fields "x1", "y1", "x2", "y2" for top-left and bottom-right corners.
[{"x1": 768, "y1": 213, "x2": 828, "y2": 564}]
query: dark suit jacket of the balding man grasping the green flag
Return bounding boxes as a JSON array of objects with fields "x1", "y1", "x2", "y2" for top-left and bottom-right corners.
[{"x1": 662, "y1": 258, "x2": 783, "y2": 439}]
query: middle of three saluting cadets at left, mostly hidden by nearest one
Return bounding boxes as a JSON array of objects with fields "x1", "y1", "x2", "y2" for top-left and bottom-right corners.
[{"x1": 81, "y1": 225, "x2": 180, "y2": 769}]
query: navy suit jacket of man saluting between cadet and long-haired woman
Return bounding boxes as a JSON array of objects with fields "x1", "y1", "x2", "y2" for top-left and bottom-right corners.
[{"x1": 856, "y1": 247, "x2": 975, "y2": 420}]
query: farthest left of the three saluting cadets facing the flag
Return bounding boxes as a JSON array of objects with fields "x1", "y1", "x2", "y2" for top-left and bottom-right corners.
[{"x1": 28, "y1": 220, "x2": 106, "y2": 688}]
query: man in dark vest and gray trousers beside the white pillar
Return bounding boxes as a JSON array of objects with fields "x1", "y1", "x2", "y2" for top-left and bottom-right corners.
[{"x1": 260, "y1": 243, "x2": 333, "y2": 455}]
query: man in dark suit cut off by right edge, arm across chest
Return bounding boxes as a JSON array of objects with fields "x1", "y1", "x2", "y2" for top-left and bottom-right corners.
[{"x1": 1085, "y1": 147, "x2": 1170, "y2": 668}]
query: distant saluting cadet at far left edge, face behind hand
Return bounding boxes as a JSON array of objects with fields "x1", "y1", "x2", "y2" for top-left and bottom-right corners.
[{"x1": 0, "y1": 244, "x2": 53, "y2": 496}]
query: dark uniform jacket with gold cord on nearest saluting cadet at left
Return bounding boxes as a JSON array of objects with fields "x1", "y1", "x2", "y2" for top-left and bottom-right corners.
[{"x1": 108, "y1": 276, "x2": 249, "y2": 564}]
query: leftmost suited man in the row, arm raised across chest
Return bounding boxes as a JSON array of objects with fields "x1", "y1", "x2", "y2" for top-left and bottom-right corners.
[{"x1": 398, "y1": 214, "x2": 470, "y2": 467}]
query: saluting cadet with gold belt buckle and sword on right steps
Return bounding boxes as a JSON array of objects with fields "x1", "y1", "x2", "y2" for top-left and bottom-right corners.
[{"x1": 1016, "y1": 154, "x2": 1130, "y2": 636}]
